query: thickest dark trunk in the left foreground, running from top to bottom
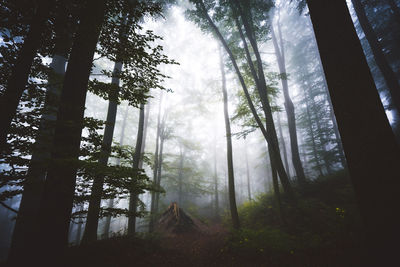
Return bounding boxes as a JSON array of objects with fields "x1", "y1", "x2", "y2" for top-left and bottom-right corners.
[{"x1": 33, "y1": 0, "x2": 106, "y2": 262}]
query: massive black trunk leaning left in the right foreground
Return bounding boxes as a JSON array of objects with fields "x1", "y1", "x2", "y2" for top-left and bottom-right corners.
[{"x1": 307, "y1": 0, "x2": 400, "y2": 266}]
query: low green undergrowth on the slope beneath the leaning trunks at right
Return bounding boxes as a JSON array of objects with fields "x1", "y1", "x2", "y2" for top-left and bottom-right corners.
[{"x1": 224, "y1": 171, "x2": 362, "y2": 266}]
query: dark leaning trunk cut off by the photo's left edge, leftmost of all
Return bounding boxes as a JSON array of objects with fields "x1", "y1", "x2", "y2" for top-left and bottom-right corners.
[{"x1": 0, "y1": 0, "x2": 54, "y2": 153}]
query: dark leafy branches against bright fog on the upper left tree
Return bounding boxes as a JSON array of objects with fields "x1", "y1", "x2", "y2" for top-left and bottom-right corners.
[{"x1": 89, "y1": 1, "x2": 177, "y2": 107}]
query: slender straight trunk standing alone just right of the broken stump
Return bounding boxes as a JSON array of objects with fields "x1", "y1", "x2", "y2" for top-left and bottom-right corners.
[{"x1": 220, "y1": 49, "x2": 240, "y2": 229}]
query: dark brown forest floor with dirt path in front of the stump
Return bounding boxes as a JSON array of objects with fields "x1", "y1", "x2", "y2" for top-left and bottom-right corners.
[{"x1": 64, "y1": 224, "x2": 255, "y2": 266}]
